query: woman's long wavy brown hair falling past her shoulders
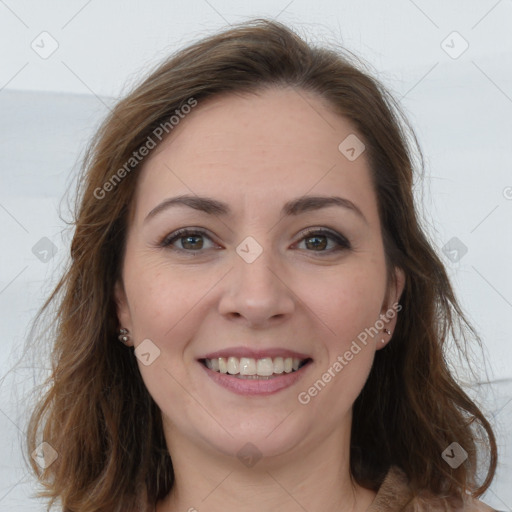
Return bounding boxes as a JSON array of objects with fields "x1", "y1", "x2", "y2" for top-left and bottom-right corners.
[{"x1": 23, "y1": 19, "x2": 497, "y2": 512}]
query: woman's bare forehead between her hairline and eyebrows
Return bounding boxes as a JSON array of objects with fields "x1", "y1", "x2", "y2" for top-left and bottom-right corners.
[{"x1": 135, "y1": 88, "x2": 376, "y2": 226}]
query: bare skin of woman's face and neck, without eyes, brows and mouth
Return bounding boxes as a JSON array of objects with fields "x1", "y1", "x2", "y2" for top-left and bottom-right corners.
[{"x1": 115, "y1": 88, "x2": 405, "y2": 512}]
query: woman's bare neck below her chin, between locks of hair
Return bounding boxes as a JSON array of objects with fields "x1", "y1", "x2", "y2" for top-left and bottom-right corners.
[{"x1": 157, "y1": 420, "x2": 375, "y2": 512}]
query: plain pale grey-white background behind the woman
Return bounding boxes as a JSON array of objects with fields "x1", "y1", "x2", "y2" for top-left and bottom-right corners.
[{"x1": 0, "y1": 0, "x2": 512, "y2": 511}]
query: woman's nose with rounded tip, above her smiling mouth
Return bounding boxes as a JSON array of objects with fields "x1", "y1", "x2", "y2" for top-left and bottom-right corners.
[{"x1": 219, "y1": 243, "x2": 295, "y2": 328}]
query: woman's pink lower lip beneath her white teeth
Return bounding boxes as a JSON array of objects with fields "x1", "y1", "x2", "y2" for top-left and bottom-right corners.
[{"x1": 199, "y1": 361, "x2": 311, "y2": 396}]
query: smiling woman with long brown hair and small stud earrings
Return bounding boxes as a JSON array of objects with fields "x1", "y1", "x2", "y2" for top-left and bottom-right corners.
[{"x1": 28, "y1": 20, "x2": 497, "y2": 512}]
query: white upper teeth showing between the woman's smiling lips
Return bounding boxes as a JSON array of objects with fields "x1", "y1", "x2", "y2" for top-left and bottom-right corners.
[{"x1": 199, "y1": 357, "x2": 312, "y2": 380}]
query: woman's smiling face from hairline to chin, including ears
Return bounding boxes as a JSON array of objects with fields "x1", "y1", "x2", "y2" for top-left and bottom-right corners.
[{"x1": 116, "y1": 88, "x2": 403, "y2": 464}]
